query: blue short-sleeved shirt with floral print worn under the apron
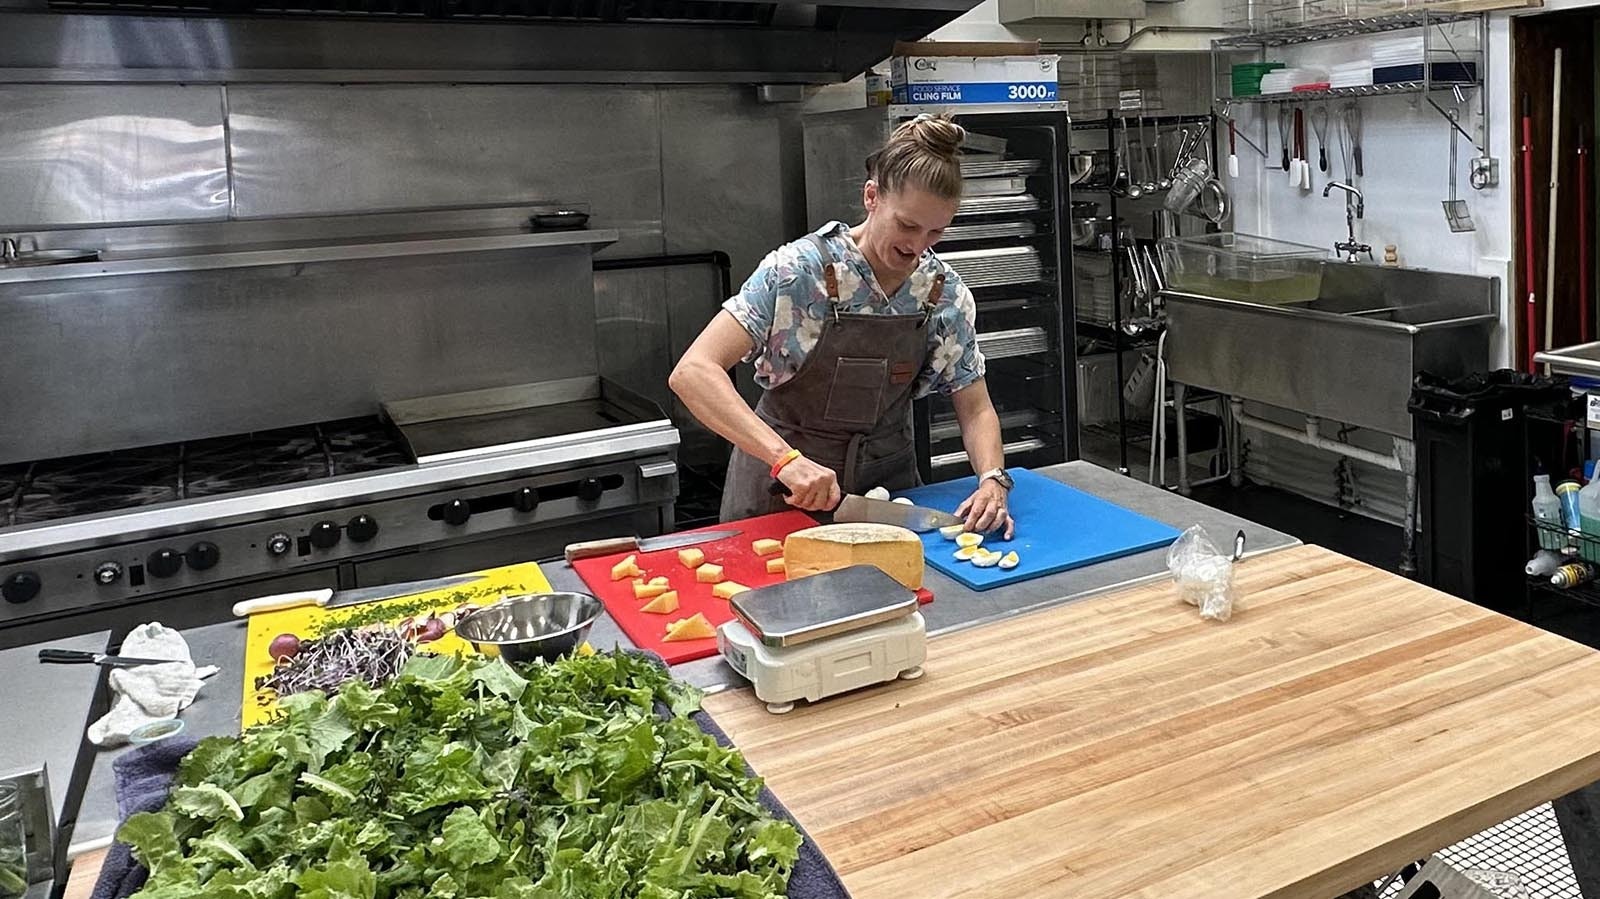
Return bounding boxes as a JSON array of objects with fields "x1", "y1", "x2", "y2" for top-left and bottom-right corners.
[{"x1": 723, "y1": 222, "x2": 984, "y2": 397}]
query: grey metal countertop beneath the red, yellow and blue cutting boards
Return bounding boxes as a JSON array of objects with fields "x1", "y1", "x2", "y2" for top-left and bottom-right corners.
[{"x1": 21, "y1": 462, "x2": 1299, "y2": 854}]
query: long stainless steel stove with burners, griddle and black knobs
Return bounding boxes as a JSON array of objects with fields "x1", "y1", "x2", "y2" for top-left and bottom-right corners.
[{"x1": 0, "y1": 378, "x2": 678, "y2": 648}]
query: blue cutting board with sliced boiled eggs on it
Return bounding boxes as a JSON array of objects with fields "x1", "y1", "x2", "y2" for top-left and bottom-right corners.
[{"x1": 901, "y1": 469, "x2": 1178, "y2": 590}]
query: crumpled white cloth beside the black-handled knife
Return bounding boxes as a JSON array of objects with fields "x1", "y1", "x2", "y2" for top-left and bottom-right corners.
[{"x1": 90, "y1": 622, "x2": 218, "y2": 745}]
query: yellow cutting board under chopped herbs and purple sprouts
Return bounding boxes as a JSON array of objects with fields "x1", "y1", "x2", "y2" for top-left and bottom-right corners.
[{"x1": 242, "y1": 561, "x2": 550, "y2": 728}]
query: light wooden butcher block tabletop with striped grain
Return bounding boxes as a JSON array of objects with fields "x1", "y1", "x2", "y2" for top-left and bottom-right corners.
[{"x1": 706, "y1": 537, "x2": 1600, "y2": 899}]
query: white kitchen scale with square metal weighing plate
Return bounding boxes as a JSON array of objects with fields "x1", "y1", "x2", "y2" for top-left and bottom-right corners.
[{"x1": 717, "y1": 565, "x2": 928, "y2": 715}]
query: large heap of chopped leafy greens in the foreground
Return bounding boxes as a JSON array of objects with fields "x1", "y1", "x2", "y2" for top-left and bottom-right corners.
[{"x1": 117, "y1": 653, "x2": 800, "y2": 899}]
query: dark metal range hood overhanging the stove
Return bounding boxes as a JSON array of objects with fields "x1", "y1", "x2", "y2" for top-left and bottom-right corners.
[{"x1": 0, "y1": 0, "x2": 978, "y2": 83}]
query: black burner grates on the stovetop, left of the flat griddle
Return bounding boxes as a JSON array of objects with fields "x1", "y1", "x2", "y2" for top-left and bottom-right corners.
[{"x1": 0, "y1": 418, "x2": 411, "y2": 526}]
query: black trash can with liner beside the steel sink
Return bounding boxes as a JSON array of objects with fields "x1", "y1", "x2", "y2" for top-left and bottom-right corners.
[{"x1": 1408, "y1": 371, "x2": 1573, "y2": 613}]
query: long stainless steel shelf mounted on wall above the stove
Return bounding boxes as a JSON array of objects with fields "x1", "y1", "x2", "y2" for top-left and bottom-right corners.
[{"x1": 0, "y1": 229, "x2": 621, "y2": 285}]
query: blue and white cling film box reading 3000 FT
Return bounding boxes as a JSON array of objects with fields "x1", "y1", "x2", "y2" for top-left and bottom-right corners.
[{"x1": 890, "y1": 42, "x2": 1059, "y2": 106}]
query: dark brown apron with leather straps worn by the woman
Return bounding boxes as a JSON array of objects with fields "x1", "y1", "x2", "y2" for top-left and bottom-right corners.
[{"x1": 722, "y1": 234, "x2": 944, "y2": 521}]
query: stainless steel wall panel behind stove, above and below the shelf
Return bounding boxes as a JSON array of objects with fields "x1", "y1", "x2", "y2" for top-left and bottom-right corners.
[{"x1": 0, "y1": 74, "x2": 805, "y2": 462}]
